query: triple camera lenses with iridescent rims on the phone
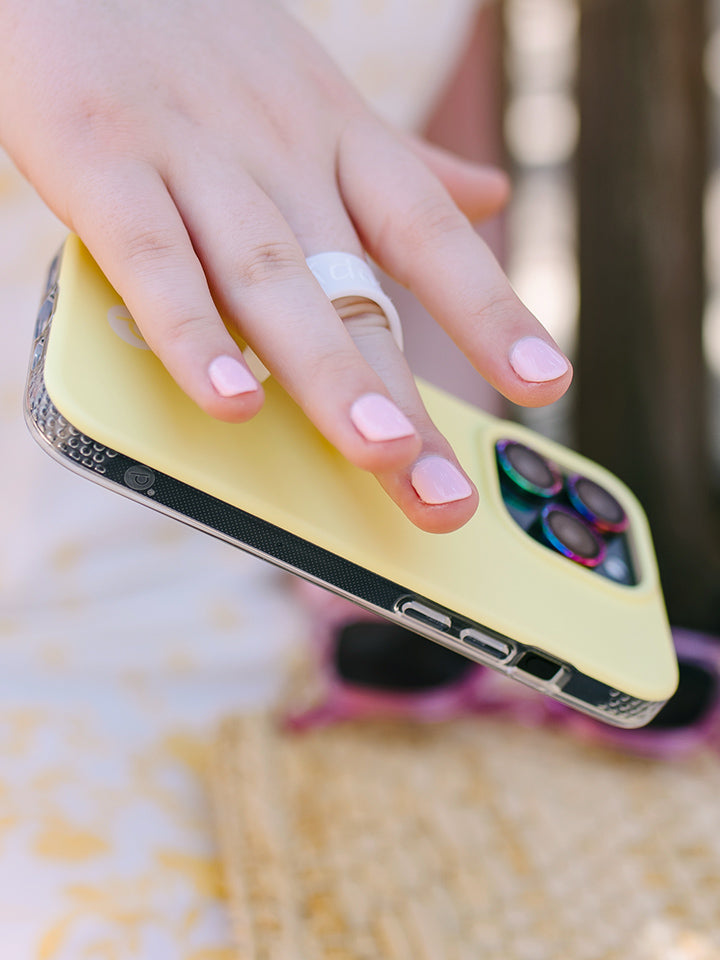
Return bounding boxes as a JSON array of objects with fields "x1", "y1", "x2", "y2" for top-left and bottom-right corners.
[{"x1": 496, "y1": 440, "x2": 629, "y2": 580}]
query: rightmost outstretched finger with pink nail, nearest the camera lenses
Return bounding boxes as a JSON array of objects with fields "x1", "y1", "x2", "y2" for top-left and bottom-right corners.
[{"x1": 338, "y1": 121, "x2": 572, "y2": 406}]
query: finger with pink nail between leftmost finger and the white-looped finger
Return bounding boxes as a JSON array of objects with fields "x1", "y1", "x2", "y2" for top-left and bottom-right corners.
[{"x1": 162, "y1": 157, "x2": 420, "y2": 472}]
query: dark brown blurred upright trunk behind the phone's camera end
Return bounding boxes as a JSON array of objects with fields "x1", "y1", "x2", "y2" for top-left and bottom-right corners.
[{"x1": 576, "y1": 0, "x2": 720, "y2": 631}]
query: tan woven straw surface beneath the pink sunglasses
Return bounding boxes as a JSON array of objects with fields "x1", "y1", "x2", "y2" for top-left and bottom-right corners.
[{"x1": 213, "y1": 716, "x2": 720, "y2": 960}]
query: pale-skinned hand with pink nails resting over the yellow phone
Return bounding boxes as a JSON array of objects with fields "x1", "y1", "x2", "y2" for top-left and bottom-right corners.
[{"x1": 0, "y1": 0, "x2": 572, "y2": 532}]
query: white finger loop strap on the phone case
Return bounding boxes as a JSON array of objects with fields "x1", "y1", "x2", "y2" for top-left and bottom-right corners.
[{"x1": 243, "y1": 251, "x2": 403, "y2": 382}]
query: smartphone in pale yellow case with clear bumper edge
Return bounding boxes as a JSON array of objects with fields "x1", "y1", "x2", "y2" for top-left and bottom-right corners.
[{"x1": 26, "y1": 236, "x2": 678, "y2": 727}]
